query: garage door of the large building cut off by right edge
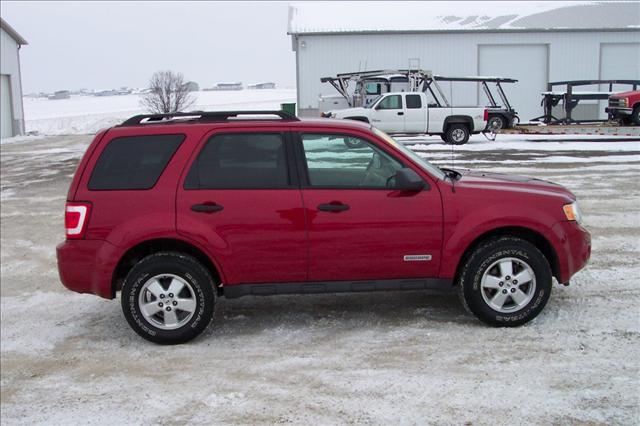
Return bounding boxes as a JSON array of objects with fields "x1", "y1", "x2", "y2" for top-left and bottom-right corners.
[{"x1": 600, "y1": 43, "x2": 640, "y2": 118}]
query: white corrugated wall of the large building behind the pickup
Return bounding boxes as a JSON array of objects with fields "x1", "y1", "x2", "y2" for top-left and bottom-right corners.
[{"x1": 297, "y1": 31, "x2": 640, "y2": 120}]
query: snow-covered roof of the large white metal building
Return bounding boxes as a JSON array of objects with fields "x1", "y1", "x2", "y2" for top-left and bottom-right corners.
[{"x1": 288, "y1": 1, "x2": 640, "y2": 34}]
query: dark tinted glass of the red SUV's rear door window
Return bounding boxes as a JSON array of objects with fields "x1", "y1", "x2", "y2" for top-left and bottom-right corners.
[{"x1": 184, "y1": 133, "x2": 291, "y2": 189}]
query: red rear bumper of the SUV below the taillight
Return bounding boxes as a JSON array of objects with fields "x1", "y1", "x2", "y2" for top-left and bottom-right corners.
[{"x1": 56, "y1": 240, "x2": 119, "y2": 299}]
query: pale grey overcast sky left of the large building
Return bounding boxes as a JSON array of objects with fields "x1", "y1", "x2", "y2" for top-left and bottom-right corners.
[{"x1": 0, "y1": 0, "x2": 295, "y2": 94}]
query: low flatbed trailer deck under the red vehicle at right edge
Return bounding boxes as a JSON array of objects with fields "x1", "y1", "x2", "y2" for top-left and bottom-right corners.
[{"x1": 495, "y1": 123, "x2": 640, "y2": 138}]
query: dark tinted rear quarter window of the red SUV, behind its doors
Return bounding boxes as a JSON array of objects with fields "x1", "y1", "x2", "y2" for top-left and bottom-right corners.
[{"x1": 89, "y1": 135, "x2": 185, "y2": 190}]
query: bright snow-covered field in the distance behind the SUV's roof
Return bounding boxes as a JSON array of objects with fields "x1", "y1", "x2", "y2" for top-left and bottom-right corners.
[{"x1": 19, "y1": 89, "x2": 296, "y2": 136}]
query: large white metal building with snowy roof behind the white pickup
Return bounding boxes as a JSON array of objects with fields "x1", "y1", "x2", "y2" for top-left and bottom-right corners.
[{"x1": 288, "y1": 1, "x2": 640, "y2": 121}]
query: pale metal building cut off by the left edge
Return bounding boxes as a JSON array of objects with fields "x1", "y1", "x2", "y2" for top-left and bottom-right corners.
[{"x1": 0, "y1": 18, "x2": 27, "y2": 138}]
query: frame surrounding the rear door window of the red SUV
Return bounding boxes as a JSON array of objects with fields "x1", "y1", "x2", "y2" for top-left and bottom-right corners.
[{"x1": 180, "y1": 129, "x2": 300, "y2": 191}]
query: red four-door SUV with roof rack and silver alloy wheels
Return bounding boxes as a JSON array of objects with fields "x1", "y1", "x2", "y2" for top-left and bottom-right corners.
[{"x1": 57, "y1": 111, "x2": 591, "y2": 344}]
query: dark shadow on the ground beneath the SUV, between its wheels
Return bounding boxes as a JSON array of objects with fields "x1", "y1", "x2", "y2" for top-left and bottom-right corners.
[{"x1": 205, "y1": 291, "x2": 473, "y2": 339}]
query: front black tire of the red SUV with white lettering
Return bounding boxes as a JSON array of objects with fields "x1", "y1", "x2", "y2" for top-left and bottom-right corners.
[{"x1": 458, "y1": 237, "x2": 552, "y2": 327}]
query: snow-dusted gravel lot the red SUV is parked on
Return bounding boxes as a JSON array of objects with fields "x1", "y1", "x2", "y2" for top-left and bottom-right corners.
[{"x1": 0, "y1": 136, "x2": 640, "y2": 425}]
